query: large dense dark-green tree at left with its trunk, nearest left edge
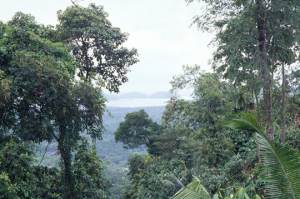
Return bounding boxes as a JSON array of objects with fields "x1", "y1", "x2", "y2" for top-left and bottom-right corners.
[{"x1": 0, "y1": 13, "x2": 117, "y2": 198}]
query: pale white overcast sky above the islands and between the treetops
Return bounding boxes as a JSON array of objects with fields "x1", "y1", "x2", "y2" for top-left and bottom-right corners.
[{"x1": 0, "y1": 0, "x2": 213, "y2": 95}]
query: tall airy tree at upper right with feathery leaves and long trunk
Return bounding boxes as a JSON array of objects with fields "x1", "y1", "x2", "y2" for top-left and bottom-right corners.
[{"x1": 187, "y1": 0, "x2": 300, "y2": 139}]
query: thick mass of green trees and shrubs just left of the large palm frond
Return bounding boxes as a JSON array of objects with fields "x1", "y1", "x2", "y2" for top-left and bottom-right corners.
[{"x1": 119, "y1": 66, "x2": 263, "y2": 198}]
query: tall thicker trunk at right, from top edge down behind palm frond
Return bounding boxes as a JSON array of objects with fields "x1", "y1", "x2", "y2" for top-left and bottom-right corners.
[{"x1": 256, "y1": 0, "x2": 274, "y2": 140}]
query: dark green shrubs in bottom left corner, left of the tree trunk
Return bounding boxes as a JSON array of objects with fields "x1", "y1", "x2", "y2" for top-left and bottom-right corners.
[{"x1": 0, "y1": 135, "x2": 61, "y2": 198}]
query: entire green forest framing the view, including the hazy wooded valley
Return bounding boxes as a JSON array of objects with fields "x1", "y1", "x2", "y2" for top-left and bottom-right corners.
[{"x1": 0, "y1": 0, "x2": 300, "y2": 199}]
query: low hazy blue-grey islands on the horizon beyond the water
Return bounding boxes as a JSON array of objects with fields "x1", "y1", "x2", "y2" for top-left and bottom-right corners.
[{"x1": 104, "y1": 91, "x2": 180, "y2": 101}]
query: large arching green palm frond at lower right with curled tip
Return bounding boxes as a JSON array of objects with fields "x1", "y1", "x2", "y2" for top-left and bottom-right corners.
[{"x1": 223, "y1": 113, "x2": 300, "y2": 199}]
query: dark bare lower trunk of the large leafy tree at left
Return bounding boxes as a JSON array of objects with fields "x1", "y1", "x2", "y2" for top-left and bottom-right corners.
[{"x1": 58, "y1": 126, "x2": 75, "y2": 199}]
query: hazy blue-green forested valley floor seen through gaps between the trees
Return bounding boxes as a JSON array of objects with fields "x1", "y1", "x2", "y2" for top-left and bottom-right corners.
[{"x1": 39, "y1": 106, "x2": 165, "y2": 195}]
